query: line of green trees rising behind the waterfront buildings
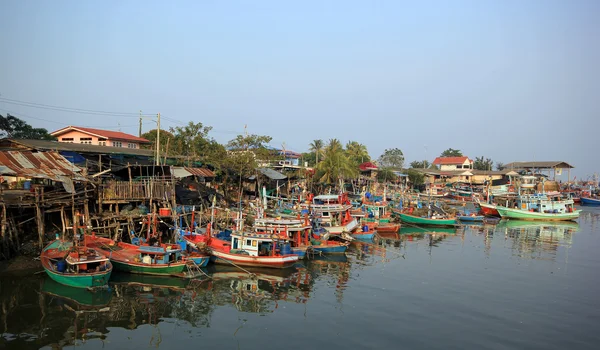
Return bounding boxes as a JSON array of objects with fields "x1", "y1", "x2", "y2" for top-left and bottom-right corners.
[{"x1": 0, "y1": 114, "x2": 504, "y2": 191}]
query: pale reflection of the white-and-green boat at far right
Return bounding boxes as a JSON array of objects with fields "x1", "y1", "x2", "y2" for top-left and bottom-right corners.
[{"x1": 493, "y1": 220, "x2": 579, "y2": 259}]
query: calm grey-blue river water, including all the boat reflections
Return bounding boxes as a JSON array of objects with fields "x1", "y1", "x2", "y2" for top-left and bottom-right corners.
[{"x1": 0, "y1": 208, "x2": 600, "y2": 350}]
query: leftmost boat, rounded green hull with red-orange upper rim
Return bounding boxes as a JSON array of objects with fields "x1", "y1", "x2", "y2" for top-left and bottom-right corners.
[{"x1": 40, "y1": 239, "x2": 112, "y2": 288}]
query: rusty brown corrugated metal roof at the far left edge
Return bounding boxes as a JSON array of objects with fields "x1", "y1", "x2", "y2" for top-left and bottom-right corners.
[{"x1": 0, "y1": 151, "x2": 86, "y2": 182}]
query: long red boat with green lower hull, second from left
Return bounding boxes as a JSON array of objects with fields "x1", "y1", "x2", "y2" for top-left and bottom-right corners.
[{"x1": 86, "y1": 234, "x2": 201, "y2": 277}]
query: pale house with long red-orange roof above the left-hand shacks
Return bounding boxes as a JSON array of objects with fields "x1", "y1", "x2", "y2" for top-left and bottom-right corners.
[{"x1": 50, "y1": 125, "x2": 150, "y2": 149}]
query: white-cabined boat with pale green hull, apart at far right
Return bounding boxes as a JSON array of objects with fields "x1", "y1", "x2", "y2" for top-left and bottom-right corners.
[{"x1": 497, "y1": 193, "x2": 581, "y2": 221}]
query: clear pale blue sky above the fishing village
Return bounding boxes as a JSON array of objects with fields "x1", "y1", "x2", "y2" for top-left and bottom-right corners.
[{"x1": 0, "y1": 0, "x2": 600, "y2": 179}]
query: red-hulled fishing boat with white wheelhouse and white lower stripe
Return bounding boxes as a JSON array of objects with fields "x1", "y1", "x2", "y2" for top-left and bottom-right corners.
[{"x1": 183, "y1": 224, "x2": 299, "y2": 268}]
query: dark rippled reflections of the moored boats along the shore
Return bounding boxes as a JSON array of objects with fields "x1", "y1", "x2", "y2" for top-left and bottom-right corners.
[{"x1": 0, "y1": 212, "x2": 600, "y2": 349}]
